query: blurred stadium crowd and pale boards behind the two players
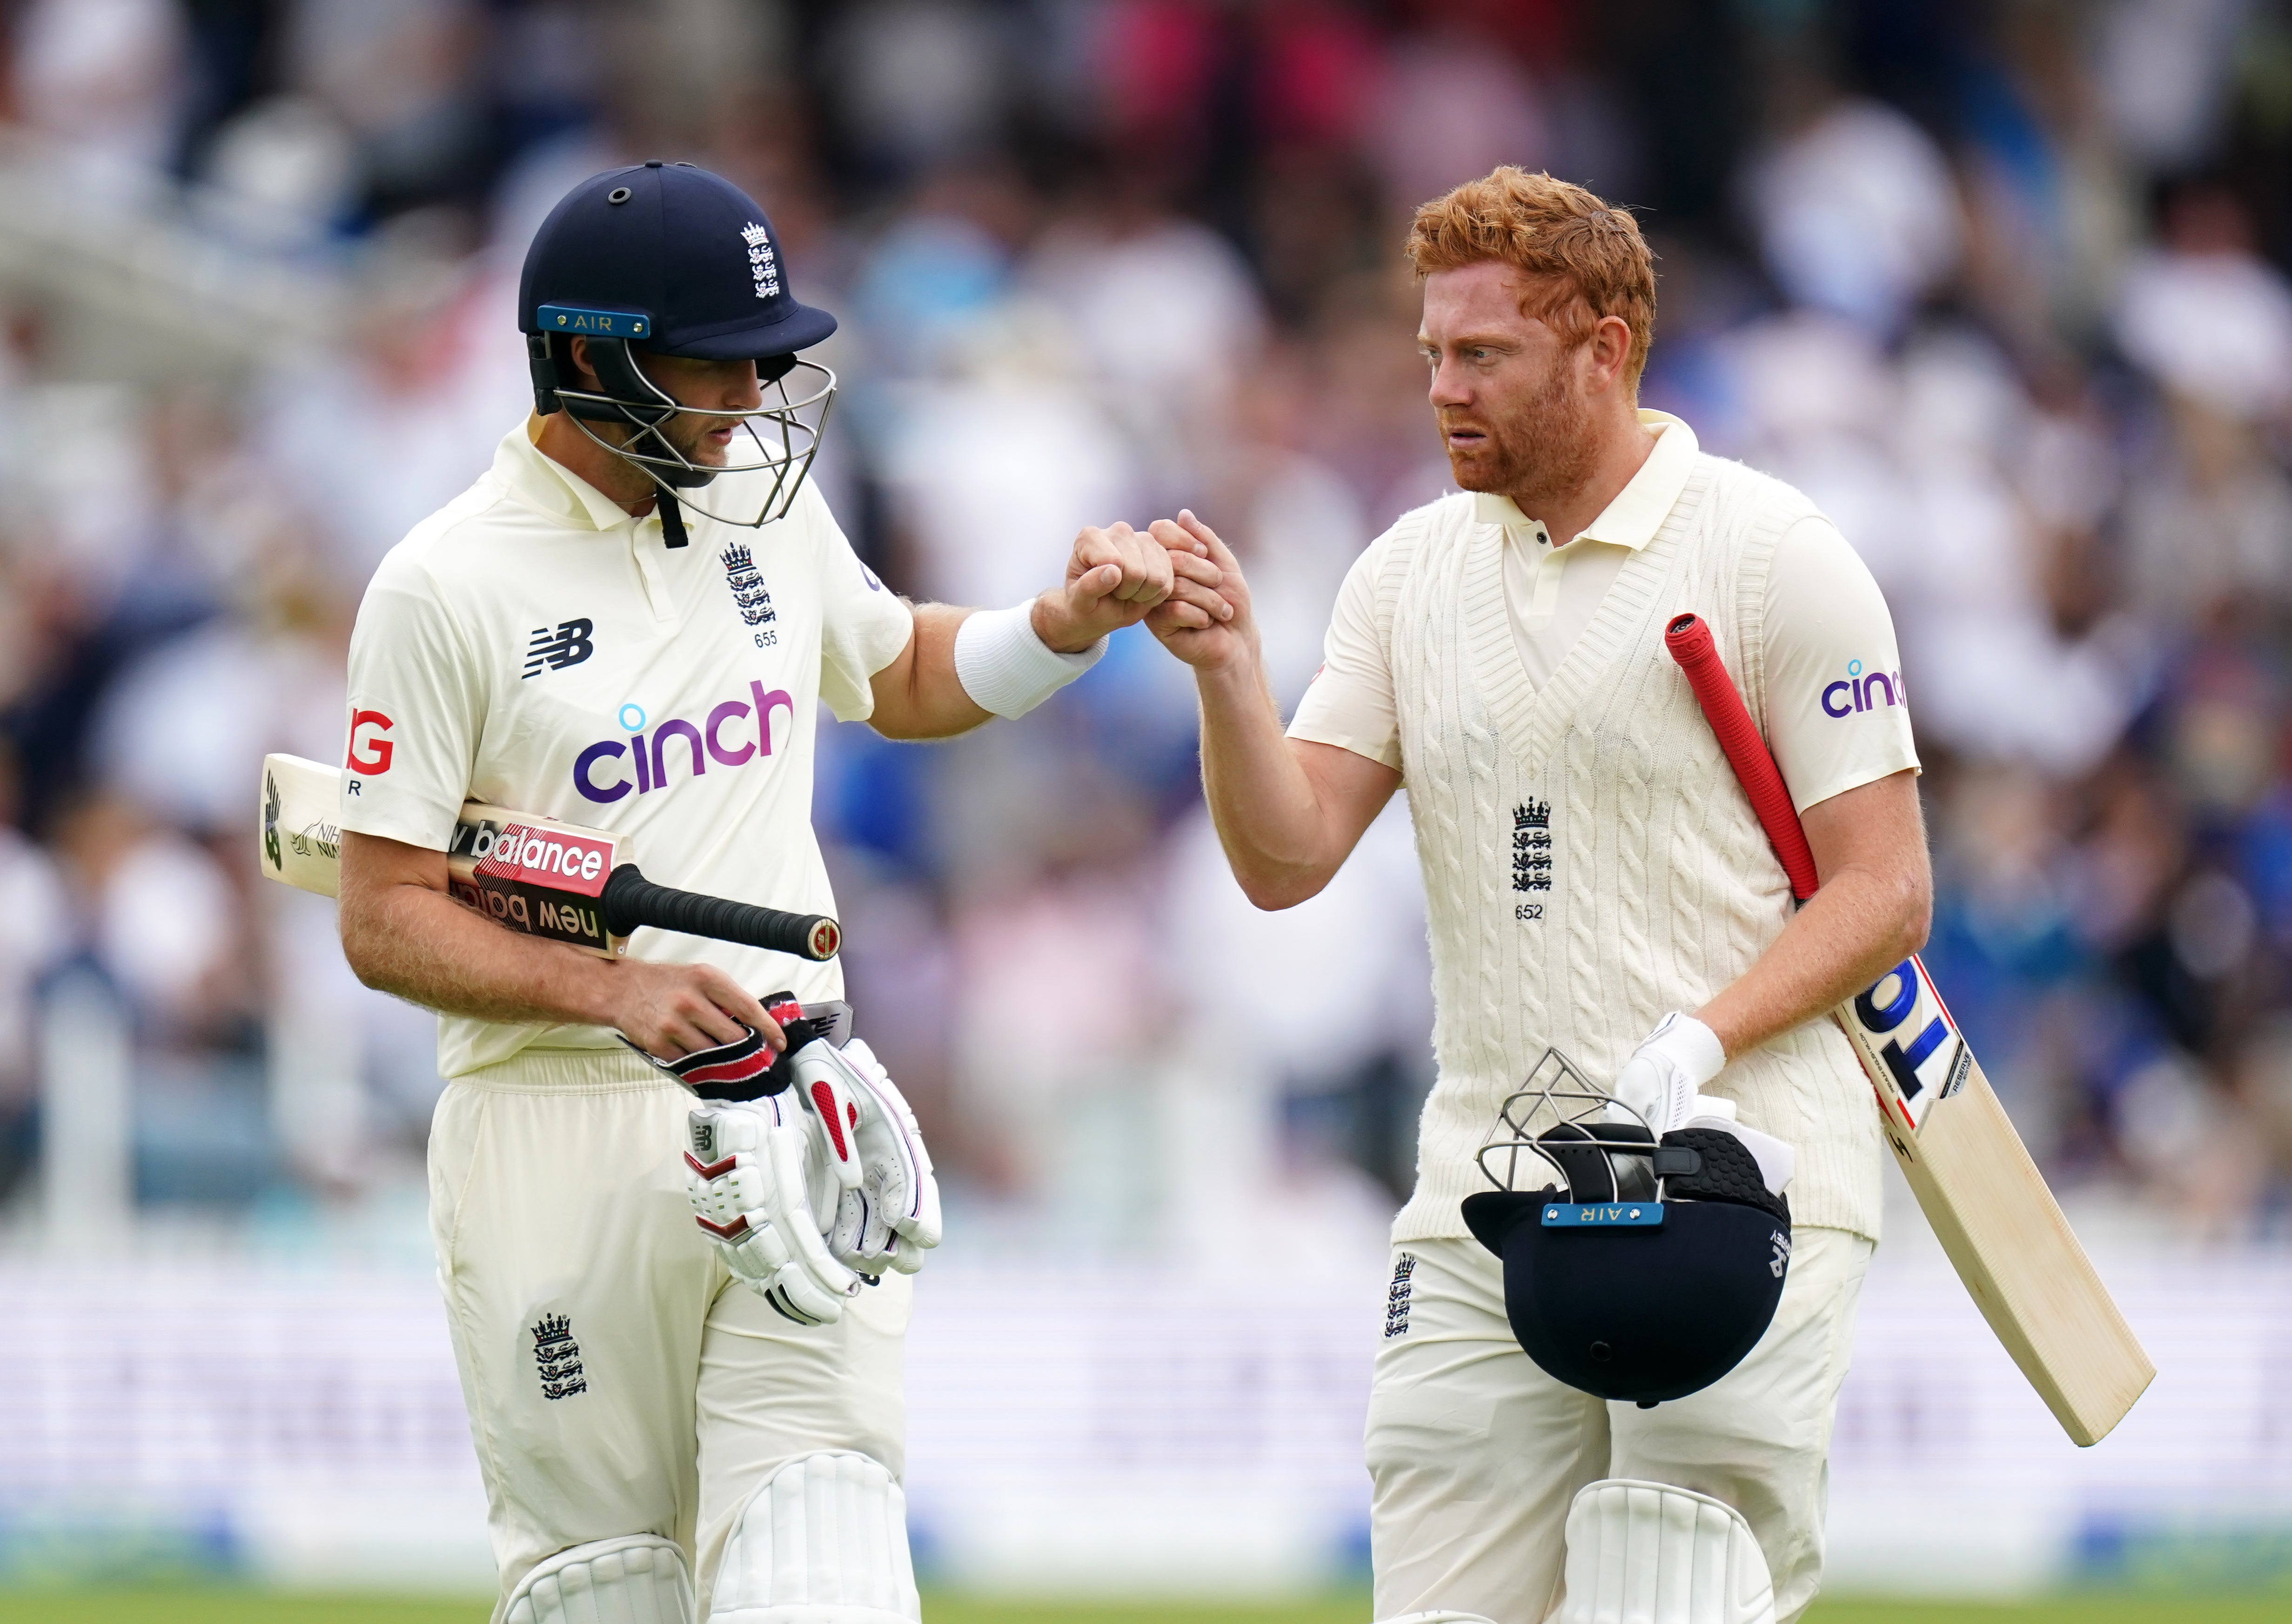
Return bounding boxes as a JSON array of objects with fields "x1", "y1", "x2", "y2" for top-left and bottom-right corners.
[{"x1": 0, "y1": 0, "x2": 2292, "y2": 1619}]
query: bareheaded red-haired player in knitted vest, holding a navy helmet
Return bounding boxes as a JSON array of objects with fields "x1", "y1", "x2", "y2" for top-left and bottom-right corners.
[{"x1": 1153, "y1": 167, "x2": 1932, "y2": 1624}]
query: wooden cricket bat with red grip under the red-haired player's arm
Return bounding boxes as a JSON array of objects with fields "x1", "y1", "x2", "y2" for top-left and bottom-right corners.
[{"x1": 1664, "y1": 614, "x2": 2157, "y2": 1445}]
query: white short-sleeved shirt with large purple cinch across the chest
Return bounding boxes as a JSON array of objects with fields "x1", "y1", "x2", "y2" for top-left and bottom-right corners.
[{"x1": 342, "y1": 419, "x2": 914, "y2": 1076}]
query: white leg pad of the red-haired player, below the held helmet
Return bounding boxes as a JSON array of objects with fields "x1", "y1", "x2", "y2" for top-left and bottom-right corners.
[{"x1": 1554, "y1": 1477, "x2": 1774, "y2": 1624}]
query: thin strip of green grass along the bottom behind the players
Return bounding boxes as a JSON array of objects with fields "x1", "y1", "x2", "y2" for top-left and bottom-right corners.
[{"x1": 0, "y1": 1587, "x2": 2292, "y2": 1624}]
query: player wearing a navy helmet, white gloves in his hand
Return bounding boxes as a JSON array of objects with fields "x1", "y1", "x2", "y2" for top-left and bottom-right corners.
[{"x1": 328, "y1": 163, "x2": 1217, "y2": 1624}]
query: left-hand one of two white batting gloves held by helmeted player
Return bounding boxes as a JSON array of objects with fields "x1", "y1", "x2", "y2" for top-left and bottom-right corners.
[{"x1": 685, "y1": 1081, "x2": 859, "y2": 1326}]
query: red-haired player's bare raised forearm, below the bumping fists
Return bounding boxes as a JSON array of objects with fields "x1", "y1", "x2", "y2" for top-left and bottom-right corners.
[{"x1": 1196, "y1": 657, "x2": 1346, "y2": 909}]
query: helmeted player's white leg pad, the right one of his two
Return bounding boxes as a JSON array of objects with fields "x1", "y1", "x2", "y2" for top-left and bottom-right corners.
[{"x1": 708, "y1": 1452, "x2": 924, "y2": 1624}]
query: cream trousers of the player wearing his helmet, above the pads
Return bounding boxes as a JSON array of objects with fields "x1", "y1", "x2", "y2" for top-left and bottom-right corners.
[{"x1": 429, "y1": 1049, "x2": 912, "y2": 1624}]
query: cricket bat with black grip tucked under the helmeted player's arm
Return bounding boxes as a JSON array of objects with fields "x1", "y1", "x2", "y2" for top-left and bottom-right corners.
[{"x1": 261, "y1": 756, "x2": 841, "y2": 960}]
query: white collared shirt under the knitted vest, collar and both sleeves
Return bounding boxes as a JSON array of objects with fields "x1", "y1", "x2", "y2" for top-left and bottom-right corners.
[{"x1": 1288, "y1": 412, "x2": 1918, "y2": 813}]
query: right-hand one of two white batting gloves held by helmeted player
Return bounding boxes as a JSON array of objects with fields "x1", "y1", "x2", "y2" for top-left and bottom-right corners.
[{"x1": 789, "y1": 1037, "x2": 940, "y2": 1278}]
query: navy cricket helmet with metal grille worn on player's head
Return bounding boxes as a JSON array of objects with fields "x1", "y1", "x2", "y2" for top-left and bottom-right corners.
[{"x1": 518, "y1": 158, "x2": 837, "y2": 548}]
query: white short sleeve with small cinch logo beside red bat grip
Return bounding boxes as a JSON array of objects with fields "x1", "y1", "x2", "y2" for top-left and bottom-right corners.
[{"x1": 1767, "y1": 515, "x2": 1918, "y2": 813}]
